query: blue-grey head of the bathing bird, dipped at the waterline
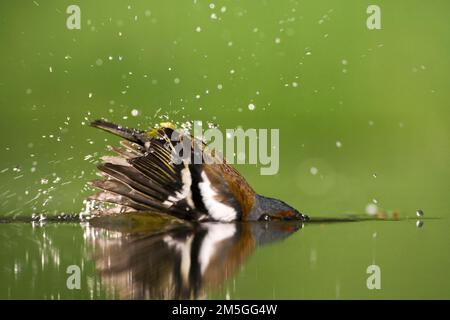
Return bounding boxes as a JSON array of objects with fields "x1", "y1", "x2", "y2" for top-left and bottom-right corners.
[{"x1": 250, "y1": 195, "x2": 309, "y2": 221}]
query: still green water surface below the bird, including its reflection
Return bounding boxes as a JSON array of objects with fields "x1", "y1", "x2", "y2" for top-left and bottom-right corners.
[{"x1": 0, "y1": 215, "x2": 450, "y2": 299}]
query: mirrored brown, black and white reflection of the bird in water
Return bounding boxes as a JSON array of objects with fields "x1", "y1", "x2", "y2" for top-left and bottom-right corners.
[{"x1": 86, "y1": 215, "x2": 302, "y2": 299}]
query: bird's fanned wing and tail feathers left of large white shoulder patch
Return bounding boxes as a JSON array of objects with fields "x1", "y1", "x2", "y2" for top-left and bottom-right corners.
[{"x1": 89, "y1": 120, "x2": 203, "y2": 220}]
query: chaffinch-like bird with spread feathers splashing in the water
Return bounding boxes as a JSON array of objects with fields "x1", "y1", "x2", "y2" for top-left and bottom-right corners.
[{"x1": 88, "y1": 119, "x2": 309, "y2": 222}]
